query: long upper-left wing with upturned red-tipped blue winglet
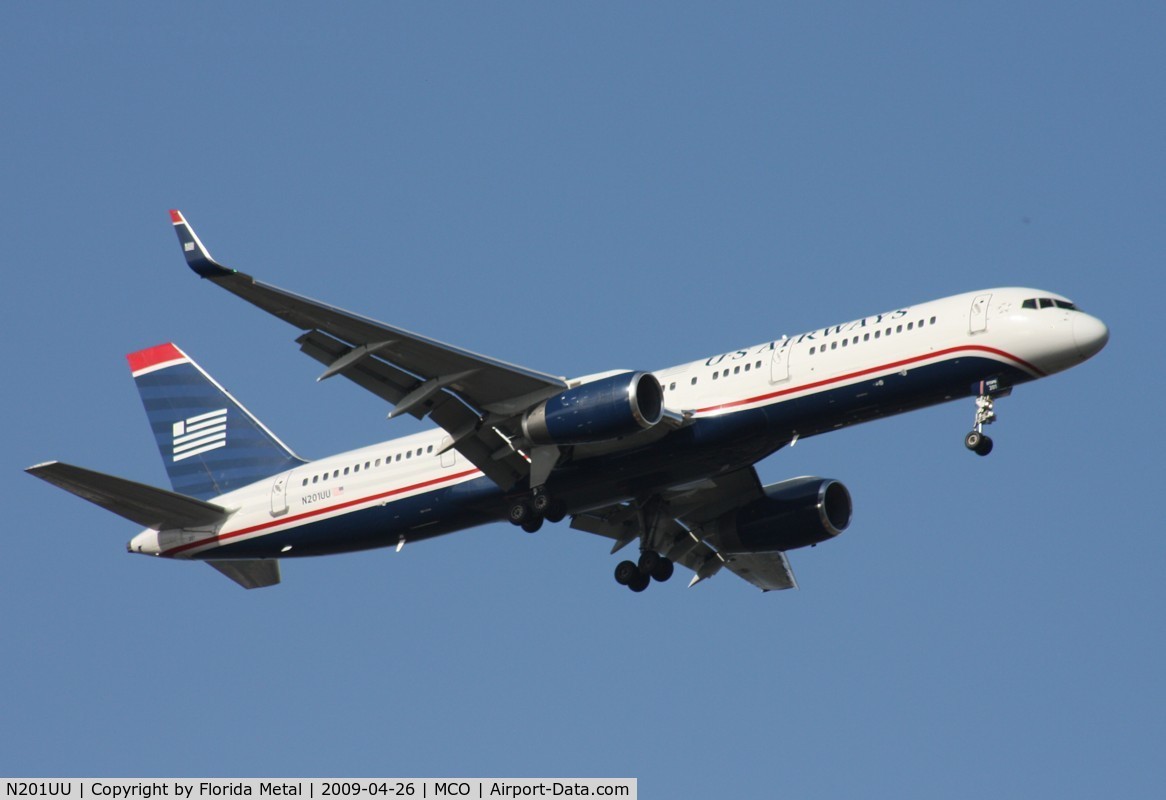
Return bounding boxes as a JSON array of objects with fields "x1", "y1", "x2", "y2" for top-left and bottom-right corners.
[{"x1": 170, "y1": 211, "x2": 568, "y2": 490}]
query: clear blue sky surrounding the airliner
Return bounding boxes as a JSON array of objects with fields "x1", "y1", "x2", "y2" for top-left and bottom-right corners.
[{"x1": 0, "y1": 2, "x2": 1166, "y2": 798}]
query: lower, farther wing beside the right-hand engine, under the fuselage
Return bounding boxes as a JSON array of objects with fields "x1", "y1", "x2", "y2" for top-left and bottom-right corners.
[{"x1": 571, "y1": 466, "x2": 798, "y2": 591}]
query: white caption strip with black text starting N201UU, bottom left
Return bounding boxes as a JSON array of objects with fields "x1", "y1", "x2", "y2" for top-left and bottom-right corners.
[{"x1": 0, "y1": 778, "x2": 638, "y2": 800}]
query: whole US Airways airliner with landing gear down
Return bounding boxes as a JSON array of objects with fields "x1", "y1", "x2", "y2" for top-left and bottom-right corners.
[{"x1": 27, "y1": 211, "x2": 1109, "y2": 592}]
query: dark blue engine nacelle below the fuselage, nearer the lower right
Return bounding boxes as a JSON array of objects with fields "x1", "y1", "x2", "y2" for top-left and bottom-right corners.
[{"x1": 719, "y1": 478, "x2": 852, "y2": 555}]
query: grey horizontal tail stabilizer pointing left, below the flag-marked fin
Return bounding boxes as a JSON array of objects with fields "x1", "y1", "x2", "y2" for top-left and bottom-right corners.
[{"x1": 24, "y1": 461, "x2": 231, "y2": 531}]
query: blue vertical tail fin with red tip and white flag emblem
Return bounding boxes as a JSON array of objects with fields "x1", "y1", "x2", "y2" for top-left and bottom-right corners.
[{"x1": 126, "y1": 344, "x2": 304, "y2": 500}]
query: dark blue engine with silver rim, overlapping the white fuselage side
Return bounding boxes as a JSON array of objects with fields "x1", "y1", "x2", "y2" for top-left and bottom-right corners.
[{"x1": 522, "y1": 372, "x2": 663, "y2": 444}]
